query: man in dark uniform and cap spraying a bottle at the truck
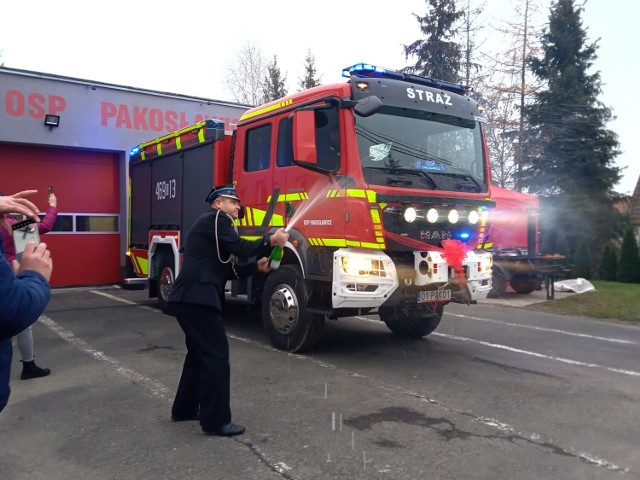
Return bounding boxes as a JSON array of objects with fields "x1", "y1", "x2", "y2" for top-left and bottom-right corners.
[{"x1": 169, "y1": 185, "x2": 289, "y2": 437}]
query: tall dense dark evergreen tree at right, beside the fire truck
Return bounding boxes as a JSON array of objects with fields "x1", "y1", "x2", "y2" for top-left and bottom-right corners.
[{"x1": 517, "y1": 0, "x2": 620, "y2": 254}]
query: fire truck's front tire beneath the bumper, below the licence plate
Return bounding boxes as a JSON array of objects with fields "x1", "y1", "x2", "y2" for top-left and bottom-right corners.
[{"x1": 379, "y1": 302, "x2": 444, "y2": 338}]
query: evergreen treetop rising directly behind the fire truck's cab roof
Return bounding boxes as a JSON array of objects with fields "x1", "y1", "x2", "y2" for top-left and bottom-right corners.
[{"x1": 404, "y1": 0, "x2": 464, "y2": 82}]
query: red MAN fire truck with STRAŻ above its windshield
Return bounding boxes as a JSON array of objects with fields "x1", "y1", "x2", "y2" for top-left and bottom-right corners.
[{"x1": 124, "y1": 64, "x2": 493, "y2": 351}]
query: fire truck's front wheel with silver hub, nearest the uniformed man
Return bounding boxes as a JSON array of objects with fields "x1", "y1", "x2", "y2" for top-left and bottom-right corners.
[{"x1": 262, "y1": 265, "x2": 324, "y2": 352}]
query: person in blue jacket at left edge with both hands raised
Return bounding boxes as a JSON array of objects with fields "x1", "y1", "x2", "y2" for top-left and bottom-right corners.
[{"x1": 0, "y1": 190, "x2": 53, "y2": 411}]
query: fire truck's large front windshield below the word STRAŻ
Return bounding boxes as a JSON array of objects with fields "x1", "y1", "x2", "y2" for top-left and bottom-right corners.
[{"x1": 355, "y1": 106, "x2": 487, "y2": 192}]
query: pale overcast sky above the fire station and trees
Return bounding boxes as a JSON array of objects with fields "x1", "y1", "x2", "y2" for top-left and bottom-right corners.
[{"x1": 0, "y1": 0, "x2": 640, "y2": 194}]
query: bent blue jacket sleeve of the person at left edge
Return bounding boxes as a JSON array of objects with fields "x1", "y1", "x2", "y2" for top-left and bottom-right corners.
[{"x1": 0, "y1": 253, "x2": 51, "y2": 340}]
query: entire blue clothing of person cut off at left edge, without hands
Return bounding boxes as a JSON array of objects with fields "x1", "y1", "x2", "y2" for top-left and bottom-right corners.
[{"x1": 0, "y1": 244, "x2": 51, "y2": 411}]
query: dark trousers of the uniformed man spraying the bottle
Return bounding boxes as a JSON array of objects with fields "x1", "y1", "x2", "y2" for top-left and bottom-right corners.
[{"x1": 171, "y1": 303, "x2": 231, "y2": 430}]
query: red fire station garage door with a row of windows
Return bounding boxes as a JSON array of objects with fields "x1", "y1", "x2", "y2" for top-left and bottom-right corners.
[{"x1": 0, "y1": 143, "x2": 124, "y2": 287}]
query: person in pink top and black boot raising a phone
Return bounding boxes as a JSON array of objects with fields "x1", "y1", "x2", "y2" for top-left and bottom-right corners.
[{"x1": 0, "y1": 185, "x2": 58, "y2": 380}]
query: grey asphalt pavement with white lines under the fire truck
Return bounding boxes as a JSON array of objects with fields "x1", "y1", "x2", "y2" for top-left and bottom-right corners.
[{"x1": 0, "y1": 287, "x2": 640, "y2": 480}]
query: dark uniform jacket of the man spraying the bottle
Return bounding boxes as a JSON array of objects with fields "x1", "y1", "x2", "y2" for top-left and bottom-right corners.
[{"x1": 169, "y1": 210, "x2": 271, "y2": 311}]
